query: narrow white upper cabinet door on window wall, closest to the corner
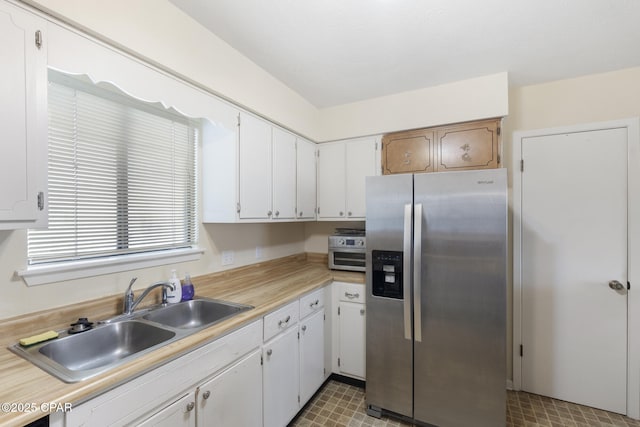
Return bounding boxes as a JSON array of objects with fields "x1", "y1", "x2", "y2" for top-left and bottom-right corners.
[{"x1": 296, "y1": 138, "x2": 316, "y2": 219}]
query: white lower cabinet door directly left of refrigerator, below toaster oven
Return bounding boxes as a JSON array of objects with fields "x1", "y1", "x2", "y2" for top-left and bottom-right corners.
[{"x1": 338, "y1": 302, "x2": 366, "y2": 379}]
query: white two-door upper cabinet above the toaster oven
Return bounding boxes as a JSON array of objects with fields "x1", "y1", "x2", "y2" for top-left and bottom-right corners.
[{"x1": 318, "y1": 136, "x2": 380, "y2": 220}]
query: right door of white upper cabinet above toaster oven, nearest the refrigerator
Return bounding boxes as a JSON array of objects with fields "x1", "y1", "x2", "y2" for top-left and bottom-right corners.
[{"x1": 346, "y1": 137, "x2": 379, "y2": 219}]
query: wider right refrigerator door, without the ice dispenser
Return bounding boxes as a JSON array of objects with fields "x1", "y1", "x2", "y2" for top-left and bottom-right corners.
[{"x1": 412, "y1": 169, "x2": 507, "y2": 427}]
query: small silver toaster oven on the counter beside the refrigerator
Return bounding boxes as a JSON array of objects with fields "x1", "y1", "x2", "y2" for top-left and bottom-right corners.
[{"x1": 329, "y1": 228, "x2": 366, "y2": 271}]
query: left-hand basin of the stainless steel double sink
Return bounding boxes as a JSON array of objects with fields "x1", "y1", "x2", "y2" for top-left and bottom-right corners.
[{"x1": 39, "y1": 320, "x2": 176, "y2": 371}]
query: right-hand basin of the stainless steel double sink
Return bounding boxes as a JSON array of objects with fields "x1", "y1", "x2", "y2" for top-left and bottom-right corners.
[{"x1": 143, "y1": 299, "x2": 253, "y2": 329}]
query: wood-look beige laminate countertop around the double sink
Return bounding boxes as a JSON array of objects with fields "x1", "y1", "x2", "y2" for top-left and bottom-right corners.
[{"x1": 0, "y1": 254, "x2": 364, "y2": 426}]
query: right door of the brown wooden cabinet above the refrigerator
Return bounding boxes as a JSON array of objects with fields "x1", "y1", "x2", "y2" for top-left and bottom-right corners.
[{"x1": 436, "y1": 119, "x2": 500, "y2": 172}]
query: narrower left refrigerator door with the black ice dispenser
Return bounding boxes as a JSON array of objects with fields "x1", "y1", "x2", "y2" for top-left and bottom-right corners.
[{"x1": 366, "y1": 175, "x2": 413, "y2": 417}]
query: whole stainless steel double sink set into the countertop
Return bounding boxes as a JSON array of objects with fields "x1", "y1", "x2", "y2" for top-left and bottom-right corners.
[{"x1": 9, "y1": 298, "x2": 253, "y2": 383}]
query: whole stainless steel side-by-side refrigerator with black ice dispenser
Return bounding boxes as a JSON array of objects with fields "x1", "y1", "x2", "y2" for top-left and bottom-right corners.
[{"x1": 366, "y1": 169, "x2": 507, "y2": 427}]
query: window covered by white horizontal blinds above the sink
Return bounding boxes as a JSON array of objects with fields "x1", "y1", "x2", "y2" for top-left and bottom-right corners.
[{"x1": 28, "y1": 72, "x2": 197, "y2": 264}]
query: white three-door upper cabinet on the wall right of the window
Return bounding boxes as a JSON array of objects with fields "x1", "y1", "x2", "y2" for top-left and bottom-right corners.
[{"x1": 202, "y1": 110, "x2": 316, "y2": 222}]
